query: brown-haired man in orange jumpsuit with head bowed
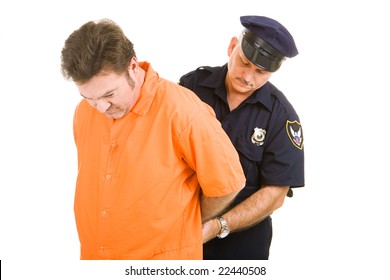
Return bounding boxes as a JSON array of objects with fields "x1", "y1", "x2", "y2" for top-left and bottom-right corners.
[{"x1": 61, "y1": 20, "x2": 245, "y2": 259}]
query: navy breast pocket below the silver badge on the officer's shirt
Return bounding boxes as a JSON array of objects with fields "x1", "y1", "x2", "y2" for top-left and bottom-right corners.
[{"x1": 235, "y1": 138, "x2": 264, "y2": 184}]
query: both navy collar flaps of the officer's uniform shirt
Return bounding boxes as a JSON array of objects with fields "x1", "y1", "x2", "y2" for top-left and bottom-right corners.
[{"x1": 200, "y1": 63, "x2": 272, "y2": 110}]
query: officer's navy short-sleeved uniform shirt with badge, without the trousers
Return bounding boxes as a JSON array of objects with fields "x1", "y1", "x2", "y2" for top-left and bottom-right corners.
[{"x1": 179, "y1": 64, "x2": 304, "y2": 200}]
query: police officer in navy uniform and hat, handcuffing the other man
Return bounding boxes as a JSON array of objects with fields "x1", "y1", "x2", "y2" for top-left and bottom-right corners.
[{"x1": 179, "y1": 16, "x2": 304, "y2": 260}]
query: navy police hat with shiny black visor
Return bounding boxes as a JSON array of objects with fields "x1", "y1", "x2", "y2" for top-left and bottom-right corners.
[{"x1": 240, "y1": 16, "x2": 298, "y2": 72}]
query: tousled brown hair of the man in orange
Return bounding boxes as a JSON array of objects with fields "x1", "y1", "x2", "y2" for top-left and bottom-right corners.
[{"x1": 61, "y1": 19, "x2": 135, "y2": 84}]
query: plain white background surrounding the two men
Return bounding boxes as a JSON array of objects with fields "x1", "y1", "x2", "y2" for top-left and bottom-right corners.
[{"x1": 0, "y1": 0, "x2": 390, "y2": 279}]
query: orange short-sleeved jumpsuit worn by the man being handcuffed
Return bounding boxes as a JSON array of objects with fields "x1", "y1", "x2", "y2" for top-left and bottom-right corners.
[{"x1": 74, "y1": 62, "x2": 245, "y2": 260}]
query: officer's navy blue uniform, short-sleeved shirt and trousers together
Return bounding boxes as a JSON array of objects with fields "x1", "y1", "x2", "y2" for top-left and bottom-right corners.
[{"x1": 179, "y1": 64, "x2": 304, "y2": 259}]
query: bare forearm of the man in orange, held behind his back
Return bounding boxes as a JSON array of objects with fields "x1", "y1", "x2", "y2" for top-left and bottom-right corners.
[{"x1": 200, "y1": 191, "x2": 239, "y2": 223}]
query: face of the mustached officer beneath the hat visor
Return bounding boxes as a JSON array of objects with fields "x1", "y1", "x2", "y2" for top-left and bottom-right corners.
[{"x1": 227, "y1": 37, "x2": 272, "y2": 94}]
